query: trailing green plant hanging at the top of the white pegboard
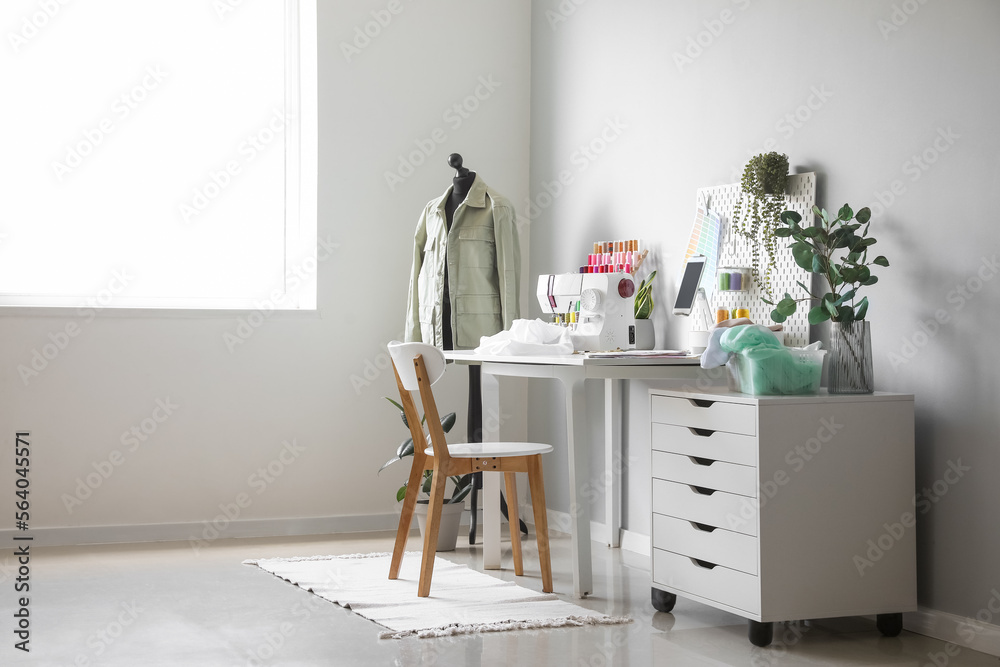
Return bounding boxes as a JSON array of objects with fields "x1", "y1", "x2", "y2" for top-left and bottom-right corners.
[{"x1": 732, "y1": 152, "x2": 788, "y2": 297}]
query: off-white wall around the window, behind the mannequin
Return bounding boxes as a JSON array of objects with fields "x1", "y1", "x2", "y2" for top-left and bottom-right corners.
[{"x1": 0, "y1": 0, "x2": 530, "y2": 540}]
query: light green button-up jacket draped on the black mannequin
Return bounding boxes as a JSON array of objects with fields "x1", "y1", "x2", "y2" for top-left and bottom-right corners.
[{"x1": 404, "y1": 175, "x2": 521, "y2": 350}]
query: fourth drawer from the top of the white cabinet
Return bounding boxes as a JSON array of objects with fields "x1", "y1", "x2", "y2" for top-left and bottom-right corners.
[{"x1": 653, "y1": 479, "x2": 757, "y2": 536}]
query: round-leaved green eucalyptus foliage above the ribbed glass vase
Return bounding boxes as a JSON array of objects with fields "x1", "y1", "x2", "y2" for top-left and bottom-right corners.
[{"x1": 763, "y1": 204, "x2": 889, "y2": 324}]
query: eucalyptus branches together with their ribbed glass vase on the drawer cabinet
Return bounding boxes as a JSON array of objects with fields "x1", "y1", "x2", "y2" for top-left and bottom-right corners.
[{"x1": 764, "y1": 204, "x2": 889, "y2": 394}]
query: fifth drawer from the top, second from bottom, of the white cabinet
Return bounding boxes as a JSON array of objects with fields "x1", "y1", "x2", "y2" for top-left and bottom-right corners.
[{"x1": 653, "y1": 514, "x2": 757, "y2": 574}]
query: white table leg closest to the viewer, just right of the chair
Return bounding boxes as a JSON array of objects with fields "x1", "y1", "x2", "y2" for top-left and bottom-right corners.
[{"x1": 562, "y1": 377, "x2": 594, "y2": 598}]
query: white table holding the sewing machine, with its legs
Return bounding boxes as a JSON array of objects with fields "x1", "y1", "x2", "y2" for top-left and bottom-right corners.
[{"x1": 445, "y1": 350, "x2": 704, "y2": 598}]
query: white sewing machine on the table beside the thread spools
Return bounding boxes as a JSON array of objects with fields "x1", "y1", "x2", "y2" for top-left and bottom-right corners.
[{"x1": 536, "y1": 273, "x2": 636, "y2": 352}]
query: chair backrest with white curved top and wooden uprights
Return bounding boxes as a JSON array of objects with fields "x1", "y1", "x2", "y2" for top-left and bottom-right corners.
[{"x1": 388, "y1": 341, "x2": 451, "y2": 460}]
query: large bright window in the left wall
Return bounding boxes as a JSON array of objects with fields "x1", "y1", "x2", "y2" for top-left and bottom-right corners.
[{"x1": 0, "y1": 0, "x2": 317, "y2": 309}]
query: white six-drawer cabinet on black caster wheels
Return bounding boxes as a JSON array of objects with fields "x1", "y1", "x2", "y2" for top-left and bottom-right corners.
[{"x1": 650, "y1": 389, "x2": 917, "y2": 646}]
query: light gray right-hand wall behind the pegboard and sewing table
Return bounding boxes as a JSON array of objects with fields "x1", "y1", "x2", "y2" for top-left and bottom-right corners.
[{"x1": 529, "y1": 0, "x2": 1000, "y2": 616}]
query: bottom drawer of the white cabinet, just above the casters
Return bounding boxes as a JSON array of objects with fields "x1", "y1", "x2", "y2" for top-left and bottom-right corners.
[{"x1": 653, "y1": 548, "x2": 760, "y2": 614}]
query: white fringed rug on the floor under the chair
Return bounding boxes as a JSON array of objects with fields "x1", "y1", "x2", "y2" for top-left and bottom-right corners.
[{"x1": 244, "y1": 552, "x2": 631, "y2": 639}]
